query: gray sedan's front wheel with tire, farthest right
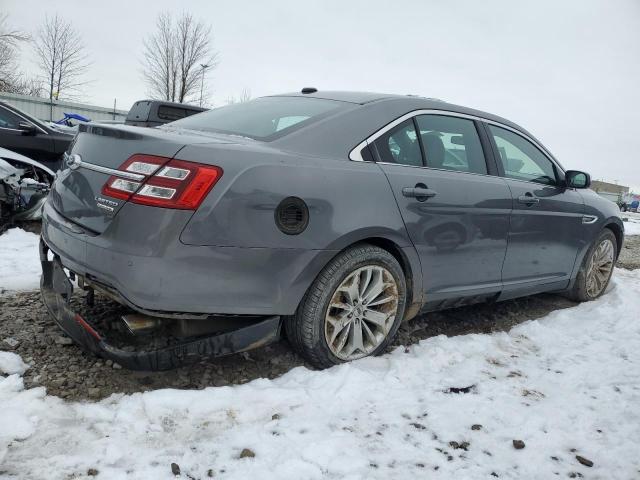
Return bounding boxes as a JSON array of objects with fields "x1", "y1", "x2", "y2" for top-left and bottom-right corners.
[{"x1": 567, "y1": 228, "x2": 618, "y2": 302}]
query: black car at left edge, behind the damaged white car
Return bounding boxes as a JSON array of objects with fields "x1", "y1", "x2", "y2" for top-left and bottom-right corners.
[{"x1": 0, "y1": 102, "x2": 73, "y2": 171}]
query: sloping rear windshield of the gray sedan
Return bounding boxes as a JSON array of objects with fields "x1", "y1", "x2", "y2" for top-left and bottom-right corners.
[{"x1": 170, "y1": 97, "x2": 347, "y2": 141}]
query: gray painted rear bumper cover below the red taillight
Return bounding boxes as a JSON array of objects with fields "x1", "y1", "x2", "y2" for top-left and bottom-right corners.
[{"x1": 42, "y1": 202, "x2": 337, "y2": 316}]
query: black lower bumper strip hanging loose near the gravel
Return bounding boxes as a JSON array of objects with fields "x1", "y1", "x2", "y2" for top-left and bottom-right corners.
[{"x1": 40, "y1": 240, "x2": 280, "y2": 371}]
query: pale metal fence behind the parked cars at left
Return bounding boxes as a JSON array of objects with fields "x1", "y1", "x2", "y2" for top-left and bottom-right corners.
[{"x1": 0, "y1": 92, "x2": 127, "y2": 121}]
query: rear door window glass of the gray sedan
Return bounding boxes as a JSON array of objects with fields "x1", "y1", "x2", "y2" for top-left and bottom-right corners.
[{"x1": 416, "y1": 115, "x2": 487, "y2": 174}]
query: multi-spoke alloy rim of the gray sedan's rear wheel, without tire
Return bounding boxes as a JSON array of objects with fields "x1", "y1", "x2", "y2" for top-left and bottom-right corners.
[{"x1": 324, "y1": 265, "x2": 399, "y2": 361}]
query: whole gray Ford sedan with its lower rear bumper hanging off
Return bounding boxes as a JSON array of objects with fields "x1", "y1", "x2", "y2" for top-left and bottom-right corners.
[{"x1": 41, "y1": 89, "x2": 624, "y2": 370}]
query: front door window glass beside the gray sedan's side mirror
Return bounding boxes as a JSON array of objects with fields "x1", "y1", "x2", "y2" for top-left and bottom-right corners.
[{"x1": 489, "y1": 125, "x2": 558, "y2": 185}]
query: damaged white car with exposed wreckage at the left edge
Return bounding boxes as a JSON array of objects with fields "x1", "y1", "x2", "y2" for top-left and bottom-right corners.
[{"x1": 0, "y1": 148, "x2": 55, "y2": 232}]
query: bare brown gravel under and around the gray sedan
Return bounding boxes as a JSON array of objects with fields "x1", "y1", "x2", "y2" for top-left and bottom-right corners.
[{"x1": 0, "y1": 237, "x2": 640, "y2": 401}]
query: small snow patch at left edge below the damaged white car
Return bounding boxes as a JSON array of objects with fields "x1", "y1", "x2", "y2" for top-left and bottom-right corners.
[{"x1": 0, "y1": 228, "x2": 42, "y2": 293}]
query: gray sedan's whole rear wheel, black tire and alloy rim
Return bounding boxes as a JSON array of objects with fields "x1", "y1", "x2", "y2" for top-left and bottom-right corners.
[{"x1": 285, "y1": 244, "x2": 407, "y2": 368}]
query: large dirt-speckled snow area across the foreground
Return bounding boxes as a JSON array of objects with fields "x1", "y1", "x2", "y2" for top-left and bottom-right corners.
[{"x1": 0, "y1": 270, "x2": 640, "y2": 480}]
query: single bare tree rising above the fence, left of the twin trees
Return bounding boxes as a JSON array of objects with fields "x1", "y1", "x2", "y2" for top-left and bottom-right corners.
[{"x1": 35, "y1": 14, "x2": 89, "y2": 100}]
